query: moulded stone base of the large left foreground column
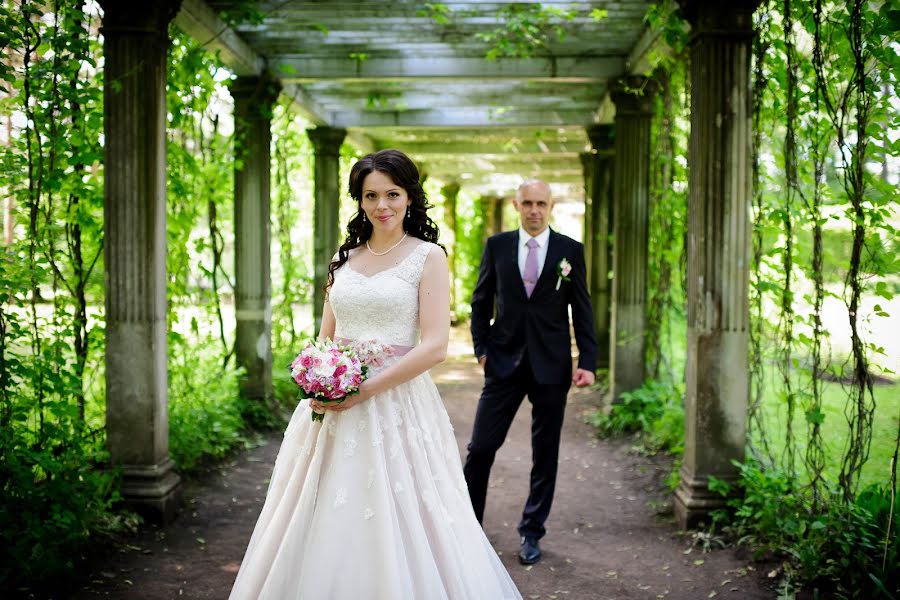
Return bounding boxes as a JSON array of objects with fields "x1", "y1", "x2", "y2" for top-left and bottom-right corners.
[{"x1": 121, "y1": 458, "x2": 181, "y2": 524}]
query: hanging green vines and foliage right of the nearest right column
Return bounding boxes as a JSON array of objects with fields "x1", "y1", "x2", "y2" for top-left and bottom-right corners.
[{"x1": 733, "y1": 0, "x2": 900, "y2": 597}]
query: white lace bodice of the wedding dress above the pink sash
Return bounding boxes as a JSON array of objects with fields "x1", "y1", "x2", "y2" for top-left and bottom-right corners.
[{"x1": 329, "y1": 242, "x2": 433, "y2": 346}]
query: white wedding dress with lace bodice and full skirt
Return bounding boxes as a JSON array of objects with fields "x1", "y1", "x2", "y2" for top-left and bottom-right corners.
[{"x1": 231, "y1": 243, "x2": 521, "y2": 600}]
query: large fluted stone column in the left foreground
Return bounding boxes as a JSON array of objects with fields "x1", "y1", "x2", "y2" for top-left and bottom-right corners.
[{"x1": 101, "y1": 1, "x2": 180, "y2": 522}]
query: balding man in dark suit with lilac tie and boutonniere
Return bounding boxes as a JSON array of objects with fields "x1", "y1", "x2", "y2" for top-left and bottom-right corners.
[{"x1": 464, "y1": 180, "x2": 597, "y2": 565}]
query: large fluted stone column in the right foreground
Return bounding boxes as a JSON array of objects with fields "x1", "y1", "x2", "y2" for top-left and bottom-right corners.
[{"x1": 675, "y1": 0, "x2": 758, "y2": 528}]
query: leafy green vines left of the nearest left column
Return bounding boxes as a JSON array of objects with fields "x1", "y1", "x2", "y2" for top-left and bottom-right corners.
[{"x1": 0, "y1": 1, "x2": 122, "y2": 589}]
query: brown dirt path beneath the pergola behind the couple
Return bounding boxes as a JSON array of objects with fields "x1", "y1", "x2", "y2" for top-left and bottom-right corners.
[{"x1": 72, "y1": 340, "x2": 775, "y2": 600}]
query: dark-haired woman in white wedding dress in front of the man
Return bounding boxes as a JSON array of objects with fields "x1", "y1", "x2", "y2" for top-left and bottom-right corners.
[{"x1": 231, "y1": 150, "x2": 521, "y2": 600}]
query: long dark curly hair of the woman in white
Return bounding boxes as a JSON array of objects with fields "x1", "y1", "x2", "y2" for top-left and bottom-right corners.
[{"x1": 325, "y1": 149, "x2": 447, "y2": 293}]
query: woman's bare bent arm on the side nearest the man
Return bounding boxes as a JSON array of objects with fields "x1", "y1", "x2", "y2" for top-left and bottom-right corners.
[{"x1": 330, "y1": 246, "x2": 450, "y2": 410}]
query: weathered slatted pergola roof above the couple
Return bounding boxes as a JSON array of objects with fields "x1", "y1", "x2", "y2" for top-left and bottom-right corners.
[{"x1": 176, "y1": 0, "x2": 660, "y2": 193}]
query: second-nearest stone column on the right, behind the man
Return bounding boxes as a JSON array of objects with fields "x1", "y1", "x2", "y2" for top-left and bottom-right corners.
[{"x1": 609, "y1": 77, "x2": 653, "y2": 402}]
